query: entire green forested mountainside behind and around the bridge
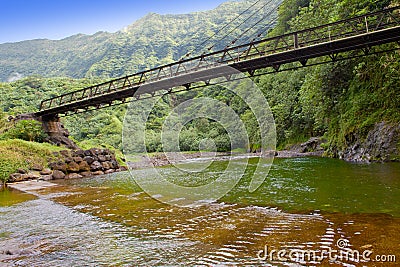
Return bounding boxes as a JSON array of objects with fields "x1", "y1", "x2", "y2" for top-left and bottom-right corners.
[{"x1": 0, "y1": 0, "x2": 400, "y2": 161}]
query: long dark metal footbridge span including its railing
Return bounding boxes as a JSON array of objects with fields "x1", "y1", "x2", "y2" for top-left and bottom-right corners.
[{"x1": 35, "y1": 7, "x2": 400, "y2": 117}]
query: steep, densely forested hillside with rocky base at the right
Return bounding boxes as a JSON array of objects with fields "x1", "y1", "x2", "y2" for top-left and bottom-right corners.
[{"x1": 257, "y1": 0, "x2": 400, "y2": 160}]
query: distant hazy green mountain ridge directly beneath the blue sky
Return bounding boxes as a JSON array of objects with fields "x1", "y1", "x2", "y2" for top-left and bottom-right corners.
[{"x1": 0, "y1": 0, "x2": 281, "y2": 81}]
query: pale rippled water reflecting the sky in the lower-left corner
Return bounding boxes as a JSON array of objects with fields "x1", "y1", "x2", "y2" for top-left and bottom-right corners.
[{"x1": 0, "y1": 199, "x2": 200, "y2": 266}]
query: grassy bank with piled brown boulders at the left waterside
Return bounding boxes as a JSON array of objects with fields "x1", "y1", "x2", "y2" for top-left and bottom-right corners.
[{"x1": 0, "y1": 139, "x2": 127, "y2": 185}]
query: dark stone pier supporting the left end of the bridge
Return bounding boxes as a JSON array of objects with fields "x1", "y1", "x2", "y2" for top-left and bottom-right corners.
[{"x1": 14, "y1": 114, "x2": 79, "y2": 149}]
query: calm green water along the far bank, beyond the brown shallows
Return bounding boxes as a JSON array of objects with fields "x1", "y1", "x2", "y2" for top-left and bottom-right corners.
[{"x1": 54, "y1": 158, "x2": 400, "y2": 217}]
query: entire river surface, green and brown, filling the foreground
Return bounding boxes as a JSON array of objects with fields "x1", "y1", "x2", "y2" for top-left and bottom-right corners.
[{"x1": 0, "y1": 158, "x2": 400, "y2": 266}]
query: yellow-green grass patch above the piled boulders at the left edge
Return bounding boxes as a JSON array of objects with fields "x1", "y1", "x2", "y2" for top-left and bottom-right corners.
[{"x1": 0, "y1": 139, "x2": 65, "y2": 183}]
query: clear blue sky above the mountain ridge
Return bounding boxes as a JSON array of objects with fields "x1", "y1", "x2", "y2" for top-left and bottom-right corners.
[{"x1": 0, "y1": 0, "x2": 227, "y2": 43}]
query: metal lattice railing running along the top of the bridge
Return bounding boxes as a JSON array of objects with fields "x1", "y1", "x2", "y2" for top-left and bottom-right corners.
[{"x1": 40, "y1": 6, "x2": 400, "y2": 111}]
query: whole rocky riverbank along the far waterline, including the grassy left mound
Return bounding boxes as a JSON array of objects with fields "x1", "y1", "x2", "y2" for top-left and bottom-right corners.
[{"x1": 0, "y1": 132, "x2": 395, "y2": 187}]
